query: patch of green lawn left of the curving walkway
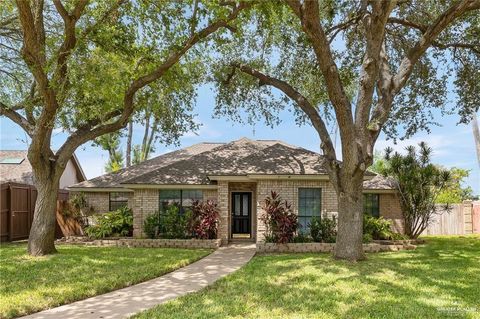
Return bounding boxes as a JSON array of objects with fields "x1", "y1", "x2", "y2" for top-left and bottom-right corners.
[{"x1": 0, "y1": 244, "x2": 210, "y2": 318}]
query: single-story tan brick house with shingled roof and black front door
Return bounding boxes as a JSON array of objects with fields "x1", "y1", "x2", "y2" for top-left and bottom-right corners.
[{"x1": 69, "y1": 138, "x2": 403, "y2": 243}]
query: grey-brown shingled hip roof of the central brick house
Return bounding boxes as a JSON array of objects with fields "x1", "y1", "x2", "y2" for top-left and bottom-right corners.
[{"x1": 71, "y1": 138, "x2": 394, "y2": 188}]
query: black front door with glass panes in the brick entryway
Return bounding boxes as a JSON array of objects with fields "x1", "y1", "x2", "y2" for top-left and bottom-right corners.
[{"x1": 232, "y1": 192, "x2": 252, "y2": 238}]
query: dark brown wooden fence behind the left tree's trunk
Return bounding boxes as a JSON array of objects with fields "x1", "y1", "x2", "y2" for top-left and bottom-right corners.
[{"x1": 0, "y1": 183, "x2": 68, "y2": 241}]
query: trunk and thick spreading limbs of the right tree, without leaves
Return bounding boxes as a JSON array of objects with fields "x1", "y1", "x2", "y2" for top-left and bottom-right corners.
[{"x1": 232, "y1": 0, "x2": 480, "y2": 260}]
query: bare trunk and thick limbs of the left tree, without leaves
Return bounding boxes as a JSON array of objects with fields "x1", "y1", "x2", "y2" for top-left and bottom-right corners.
[{"x1": 0, "y1": 0, "x2": 251, "y2": 256}]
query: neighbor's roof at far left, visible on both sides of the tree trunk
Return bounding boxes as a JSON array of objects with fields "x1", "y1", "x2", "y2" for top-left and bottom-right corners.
[{"x1": 0, "y1": 150, "x2": 86, "y2": 185}]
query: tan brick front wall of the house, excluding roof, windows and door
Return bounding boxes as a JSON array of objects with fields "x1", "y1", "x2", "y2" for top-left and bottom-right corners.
[{"x1": 79, "y1": 180, "x2": 404, "y2": 244}]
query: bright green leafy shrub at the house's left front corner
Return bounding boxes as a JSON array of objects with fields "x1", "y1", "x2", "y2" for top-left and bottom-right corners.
[{"x1": 85, "y1": 207, "x2": 133, "y2": 238}]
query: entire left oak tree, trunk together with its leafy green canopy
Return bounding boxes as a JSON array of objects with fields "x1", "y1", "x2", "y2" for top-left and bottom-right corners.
[{"x1": 0, "y1": 0, "x2": 249, "y2": 255}]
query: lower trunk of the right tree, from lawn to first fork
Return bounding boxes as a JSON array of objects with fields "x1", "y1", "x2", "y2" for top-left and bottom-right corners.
[{"x1": 334, "y1": 176, "x2": 365, "y2": 261}]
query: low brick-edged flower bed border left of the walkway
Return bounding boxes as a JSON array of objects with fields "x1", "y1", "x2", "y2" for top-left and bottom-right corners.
[{"x1": 57, "y1": 236, "x2": 221, "y2": 249}]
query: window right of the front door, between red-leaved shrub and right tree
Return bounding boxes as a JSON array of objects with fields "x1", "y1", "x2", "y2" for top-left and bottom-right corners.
[{"x1": 298, "y1": 188, "x2": 322, "y2": 233}]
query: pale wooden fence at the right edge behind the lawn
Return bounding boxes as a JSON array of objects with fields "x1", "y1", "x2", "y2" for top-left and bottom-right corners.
[{"x1": 422, "y1": 201, "x2": 480, "y2": 235}]
